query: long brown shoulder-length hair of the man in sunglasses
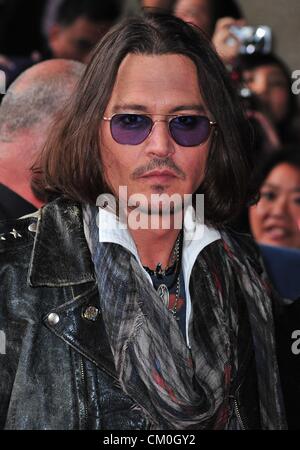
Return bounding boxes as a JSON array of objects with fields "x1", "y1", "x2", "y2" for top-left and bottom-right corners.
[{"x1": 35, "y1": 14, "x2": 252, "y2": 224}]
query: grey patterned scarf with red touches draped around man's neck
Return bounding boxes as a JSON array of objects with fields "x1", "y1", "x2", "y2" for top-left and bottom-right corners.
[{"x1": 85, "y1": 208, "x2": 286, "y2": 430}]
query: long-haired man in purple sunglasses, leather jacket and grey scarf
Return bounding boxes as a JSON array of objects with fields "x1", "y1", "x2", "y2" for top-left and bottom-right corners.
[{"x1": 0, "y1": 14, "x2": 285, "y2": 430}]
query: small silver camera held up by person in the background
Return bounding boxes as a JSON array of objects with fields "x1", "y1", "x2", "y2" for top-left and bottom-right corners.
[{"x1": 227, "y1": 25, "x2": 272, "y2": 55}]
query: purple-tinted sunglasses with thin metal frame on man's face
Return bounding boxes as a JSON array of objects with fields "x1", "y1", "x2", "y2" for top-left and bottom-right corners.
[{"x1": 103, "y1": 113, "x2": 217, "y2": 147}]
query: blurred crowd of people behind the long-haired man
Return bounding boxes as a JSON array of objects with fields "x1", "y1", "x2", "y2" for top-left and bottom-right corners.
[{"x1": 0, "y1": 0, "x2": 300, "y2": 428}]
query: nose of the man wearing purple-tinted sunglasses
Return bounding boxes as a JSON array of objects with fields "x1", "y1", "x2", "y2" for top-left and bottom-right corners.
[{"x1": 146, "y1": 120, "x2": 175, "y2": 158}]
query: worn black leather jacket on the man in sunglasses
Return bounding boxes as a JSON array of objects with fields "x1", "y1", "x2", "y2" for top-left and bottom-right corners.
[{"x1": 0, "y1": 200, "x2": 276, "y2": 430}]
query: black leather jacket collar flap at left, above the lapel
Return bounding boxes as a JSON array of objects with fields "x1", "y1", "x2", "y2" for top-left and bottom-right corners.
[{"x1": 28, "y1": 198, "x2": 95, "y2": 287}]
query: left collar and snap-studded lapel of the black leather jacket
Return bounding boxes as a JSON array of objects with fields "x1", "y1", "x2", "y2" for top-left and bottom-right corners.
[{"x1": 28, "y1": 199, "x2": 115, "y2": 377}]
